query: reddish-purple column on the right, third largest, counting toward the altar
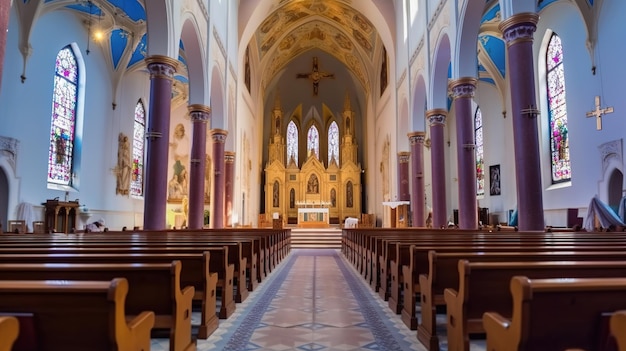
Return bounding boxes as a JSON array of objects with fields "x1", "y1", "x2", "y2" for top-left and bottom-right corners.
[{"x1": 426, "y1": 108, "x2": 448, "y2": 228}]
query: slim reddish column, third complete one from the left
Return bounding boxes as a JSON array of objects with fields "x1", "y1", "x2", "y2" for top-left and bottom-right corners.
[{"x1": 211, "y1": 129, "x2": 228, "y2": 229}]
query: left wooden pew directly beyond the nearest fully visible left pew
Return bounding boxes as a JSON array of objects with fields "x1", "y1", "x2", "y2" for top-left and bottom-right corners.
[{"x1": 0, "y1": 261, "x2": 194, "y2": 351}]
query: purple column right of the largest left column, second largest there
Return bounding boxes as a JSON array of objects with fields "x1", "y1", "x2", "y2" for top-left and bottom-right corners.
[{"x1": 187, "y1": 104, "x2": 211, "y2": 229}]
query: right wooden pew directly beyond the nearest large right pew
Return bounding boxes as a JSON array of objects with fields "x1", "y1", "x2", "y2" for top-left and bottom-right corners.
[{"x1": 444, "y1": 260, "x2": 626, "y2": 351}]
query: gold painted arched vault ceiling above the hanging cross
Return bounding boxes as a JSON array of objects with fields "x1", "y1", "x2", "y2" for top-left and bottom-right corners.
[{"x1": 250, "y1": 0, "x2": 383, "y2": 92}]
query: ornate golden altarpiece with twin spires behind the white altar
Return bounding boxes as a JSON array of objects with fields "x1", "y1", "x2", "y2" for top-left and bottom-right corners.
[{"x1": 264, "y1": 96, "x2": 362, "y2": 227}]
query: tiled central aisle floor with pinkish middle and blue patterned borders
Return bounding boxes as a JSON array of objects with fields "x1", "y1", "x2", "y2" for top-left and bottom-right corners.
[{"x1": 152, "y1": 249, "x2": 484, "y2": 351}]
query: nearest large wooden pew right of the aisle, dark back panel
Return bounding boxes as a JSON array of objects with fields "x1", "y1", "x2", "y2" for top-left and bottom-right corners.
[{"x1": 483, "y1": 277, "x2": 626, "y2": 351}]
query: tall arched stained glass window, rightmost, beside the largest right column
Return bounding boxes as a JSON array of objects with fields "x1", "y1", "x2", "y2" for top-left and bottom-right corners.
[{"x1": 546, "y1": 34, "x2": 572, "y2": 183}]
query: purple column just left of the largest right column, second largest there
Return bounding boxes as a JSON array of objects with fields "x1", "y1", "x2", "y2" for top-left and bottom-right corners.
[{"x1": 449, "y1": 77, "x2": 478, "y2": 229}]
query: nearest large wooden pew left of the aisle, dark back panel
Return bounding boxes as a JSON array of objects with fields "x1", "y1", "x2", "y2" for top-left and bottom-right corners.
[{"x1": 0, "y1": 278, "x2": 154, "y2": 351}]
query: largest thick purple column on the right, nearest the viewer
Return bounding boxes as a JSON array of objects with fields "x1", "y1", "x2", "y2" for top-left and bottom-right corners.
[{"x1": 499, "y1": 13, "x2": 544, "y2": 230}]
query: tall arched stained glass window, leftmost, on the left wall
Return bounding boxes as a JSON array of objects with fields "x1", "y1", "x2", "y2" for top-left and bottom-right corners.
[{"x1": 48, "y1": 45, "x2": 79, "y2": 186}]
